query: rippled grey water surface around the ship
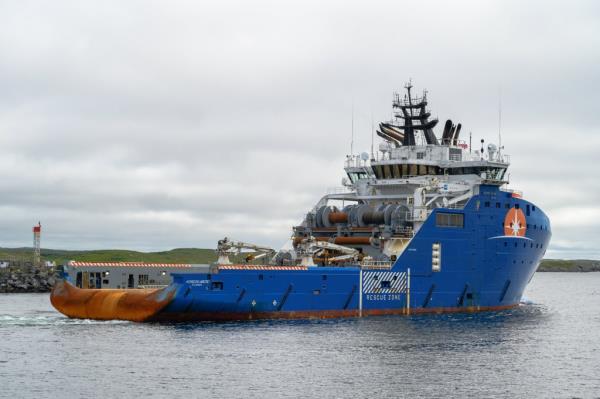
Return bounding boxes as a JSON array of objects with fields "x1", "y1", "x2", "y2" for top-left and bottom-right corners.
[{"x1": 0, "y1": 273, "x2": 600, "y2": 398}]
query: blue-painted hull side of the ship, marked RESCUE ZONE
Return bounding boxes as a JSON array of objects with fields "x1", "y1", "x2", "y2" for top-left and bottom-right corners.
[{"x1": 153, "y1": 186, "x2": 551, "y2": 320}]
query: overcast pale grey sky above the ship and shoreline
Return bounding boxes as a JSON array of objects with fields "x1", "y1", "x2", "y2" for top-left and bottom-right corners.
[{"x1": 0, "y1": 0, "x2": 600, "y2": 259}]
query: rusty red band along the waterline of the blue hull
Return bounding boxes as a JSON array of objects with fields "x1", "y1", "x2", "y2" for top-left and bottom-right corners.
[{"x1": 147, "y1": 304, "x2": 519, "y2": 322}]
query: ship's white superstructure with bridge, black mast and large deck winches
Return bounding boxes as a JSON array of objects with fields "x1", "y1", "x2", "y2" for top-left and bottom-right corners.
[{"x1": 293, "y1": 84, "x2": 509, "y2": 265}]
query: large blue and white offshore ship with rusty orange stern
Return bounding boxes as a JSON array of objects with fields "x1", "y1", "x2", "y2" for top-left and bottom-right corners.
[{"x1": 51, "y1": 83, "x2": 551, "y2": 322}]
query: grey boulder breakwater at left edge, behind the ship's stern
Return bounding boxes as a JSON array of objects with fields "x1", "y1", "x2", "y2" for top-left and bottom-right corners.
[{"x1": 0, "y1": 267, "x2": 56, "y2": 293}]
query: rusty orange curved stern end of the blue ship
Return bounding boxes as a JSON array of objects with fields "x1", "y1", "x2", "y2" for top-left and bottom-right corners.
[{"x1": 50, "y1": 280, "x2": 175, "y2": 322}]
